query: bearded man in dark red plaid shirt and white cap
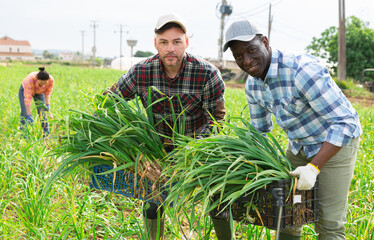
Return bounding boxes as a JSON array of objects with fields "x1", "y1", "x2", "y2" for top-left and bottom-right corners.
[{"x1": 106, "y1": 14, "x2": 225, "y2": 239}]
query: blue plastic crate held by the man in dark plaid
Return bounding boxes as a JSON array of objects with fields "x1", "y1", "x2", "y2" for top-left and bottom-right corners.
[{"x1": 90, "y1": 165, "x2": 168, "y2": 204}]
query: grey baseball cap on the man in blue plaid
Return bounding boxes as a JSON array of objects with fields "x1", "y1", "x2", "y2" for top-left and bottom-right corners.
[{"x1": 223, "y1": 19, "x2": 262, "y2": 52}]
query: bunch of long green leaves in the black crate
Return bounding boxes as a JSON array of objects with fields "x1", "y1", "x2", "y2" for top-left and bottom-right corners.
[{"x1": 164, "y1": 117, "x2": 293, "y2": 218}]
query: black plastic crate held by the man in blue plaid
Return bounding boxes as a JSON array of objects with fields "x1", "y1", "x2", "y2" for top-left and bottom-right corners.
[{"x1": 213, "y1": 179, "x2": 318, "y2": 229}]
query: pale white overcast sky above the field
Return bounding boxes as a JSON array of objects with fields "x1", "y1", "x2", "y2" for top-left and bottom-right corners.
[{"x1": 0, "y1": 0, "x2": 374, "y2": 60}]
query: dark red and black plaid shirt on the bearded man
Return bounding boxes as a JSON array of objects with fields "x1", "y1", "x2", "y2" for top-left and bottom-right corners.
[{"x1": 116, "y1": 53, "x2": 225, "y2": 139}]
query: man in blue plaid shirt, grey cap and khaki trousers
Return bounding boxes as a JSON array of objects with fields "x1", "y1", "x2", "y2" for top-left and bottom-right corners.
[{"x1": 223, "y1": 19, "x2": 362, "y2": 240}]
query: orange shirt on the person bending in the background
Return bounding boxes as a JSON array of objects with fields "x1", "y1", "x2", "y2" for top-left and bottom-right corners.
[{"x1": 22, "y1": 72, "x2": 55, "y2": 106}]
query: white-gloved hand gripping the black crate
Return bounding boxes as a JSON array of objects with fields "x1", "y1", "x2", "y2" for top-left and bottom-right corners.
[{"x1": 290, "y1": 163, "x2": 320, "y2": 190}]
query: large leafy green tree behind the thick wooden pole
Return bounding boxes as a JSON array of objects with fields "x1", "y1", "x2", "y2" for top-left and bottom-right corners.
[{"x1": 306, "y1": 16, "x2": 374, "y2": 80}]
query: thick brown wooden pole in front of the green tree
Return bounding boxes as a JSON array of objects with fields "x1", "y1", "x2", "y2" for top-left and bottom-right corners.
[{"x1": 338, "y1": 0, "x2": 347, "y2": 81}]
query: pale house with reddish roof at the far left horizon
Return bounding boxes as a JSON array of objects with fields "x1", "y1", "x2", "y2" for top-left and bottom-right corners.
[{"x1": 0, "y1": 36, "x2": 35, "y2": 60}]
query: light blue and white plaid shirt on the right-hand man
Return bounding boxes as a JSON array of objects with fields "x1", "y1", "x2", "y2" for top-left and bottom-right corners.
[{"x1": 245, "y1": 49, "x2": 362, "y2": 157}]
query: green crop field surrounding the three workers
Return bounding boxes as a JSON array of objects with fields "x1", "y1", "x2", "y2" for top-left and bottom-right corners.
[{"x1": 0, "y1": 63, "x2": 374, "y2": 240}]
